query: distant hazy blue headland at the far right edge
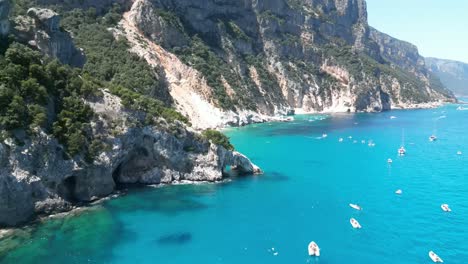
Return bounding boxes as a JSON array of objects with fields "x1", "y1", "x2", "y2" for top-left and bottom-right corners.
[{"x1": 426, "y1": 58, "x2": 468, "y2": 96}]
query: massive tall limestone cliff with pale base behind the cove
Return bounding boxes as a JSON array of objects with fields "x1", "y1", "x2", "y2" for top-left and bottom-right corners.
[{"x1": 115, "y1": 0, "x2": 453, "y2": 127}]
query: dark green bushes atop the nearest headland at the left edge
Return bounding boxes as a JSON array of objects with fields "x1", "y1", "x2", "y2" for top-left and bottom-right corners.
[{"x1": 0, "y1": 43, "x2": 99, "y2": 155}]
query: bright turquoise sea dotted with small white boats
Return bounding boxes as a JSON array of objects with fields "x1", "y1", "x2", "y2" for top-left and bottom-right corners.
[{"x1": 0, "y1": 106, "x2": 468, "y2": 264}]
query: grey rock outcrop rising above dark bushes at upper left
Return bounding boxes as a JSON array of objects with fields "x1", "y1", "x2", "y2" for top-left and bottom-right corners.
[{"x1": 14, "y1": 8, "x2": 85, "y2": 67}]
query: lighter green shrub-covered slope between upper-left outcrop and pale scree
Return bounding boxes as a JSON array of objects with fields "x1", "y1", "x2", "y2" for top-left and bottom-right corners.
[{"x1": 62, "y1": 6, "x2": 167, "y2": 98}]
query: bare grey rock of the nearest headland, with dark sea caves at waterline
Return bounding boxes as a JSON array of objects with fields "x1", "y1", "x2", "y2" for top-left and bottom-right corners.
[{"x1": 0, "y1": 92, "x2": 260, "y2": 226}]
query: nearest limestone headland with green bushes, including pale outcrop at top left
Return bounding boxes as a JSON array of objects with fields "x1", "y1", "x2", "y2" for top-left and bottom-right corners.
[{"x1": 0, "y1": 1, "x2": 260, "y2": 227}]
